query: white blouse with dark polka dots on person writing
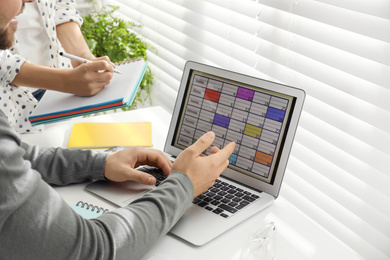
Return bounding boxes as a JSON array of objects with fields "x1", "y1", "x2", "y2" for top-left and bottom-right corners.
[{"x1": 0, "y1": 0, "x2": 83, "y2": 133}]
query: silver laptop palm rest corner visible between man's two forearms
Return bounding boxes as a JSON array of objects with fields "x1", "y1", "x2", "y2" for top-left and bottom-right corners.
[{"x1": 85, "y1": 180, "x2": 154, "y2": 207}]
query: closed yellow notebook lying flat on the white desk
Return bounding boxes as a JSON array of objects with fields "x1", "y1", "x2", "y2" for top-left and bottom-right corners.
[{"x1": 68, "y1": 122, "x2": 152, "y2": 149}]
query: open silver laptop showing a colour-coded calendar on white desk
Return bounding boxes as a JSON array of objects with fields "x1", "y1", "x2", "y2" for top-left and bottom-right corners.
[{"x1": 86, "y1": 61, "x2": 305, "y2": 246}]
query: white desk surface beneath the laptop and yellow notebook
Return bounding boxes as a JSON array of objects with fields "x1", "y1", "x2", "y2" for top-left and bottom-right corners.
[{"x1": 22, "y1": 107, "x2": 361, "y2": 260}]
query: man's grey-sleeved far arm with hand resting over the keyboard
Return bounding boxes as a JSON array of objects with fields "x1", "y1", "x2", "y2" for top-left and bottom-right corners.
[{"x1": 21, "y1": 143, "x2": 172, "y2": 185}]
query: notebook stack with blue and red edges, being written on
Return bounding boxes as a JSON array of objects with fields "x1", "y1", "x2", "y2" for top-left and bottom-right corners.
[{"x1": 28, "y1": 59, "x2": 147, "y2": 125}]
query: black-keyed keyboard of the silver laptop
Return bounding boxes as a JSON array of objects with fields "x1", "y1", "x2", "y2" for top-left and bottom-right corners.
[{"x1": 139, "y1": 166, "x2": 260, "y2": 218}]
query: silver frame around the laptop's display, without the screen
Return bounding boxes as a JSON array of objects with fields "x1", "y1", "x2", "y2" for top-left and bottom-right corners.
[{"x1": 164, "y1": 61, "x2": 305, "y2": 198}]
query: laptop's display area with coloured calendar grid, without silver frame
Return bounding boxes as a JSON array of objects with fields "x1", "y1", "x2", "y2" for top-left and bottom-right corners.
[{"x1": 173, "y1": 70, "x2": 294, "y2": 186}]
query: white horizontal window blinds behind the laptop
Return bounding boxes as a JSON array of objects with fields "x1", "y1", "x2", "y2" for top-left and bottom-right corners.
[{"x1": 102, "y1": 0, "x2": 390, "y2": 259}]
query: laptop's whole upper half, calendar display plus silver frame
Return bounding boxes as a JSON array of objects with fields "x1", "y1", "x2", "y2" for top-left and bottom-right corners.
[{"x1": 167, "y1": 62, "x2": 304, "y2": 197}]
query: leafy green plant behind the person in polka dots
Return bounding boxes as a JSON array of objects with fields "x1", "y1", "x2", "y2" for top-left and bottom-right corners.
[{"x1": 81, "y1": 6, "x2": 153, "y2": 111}]
